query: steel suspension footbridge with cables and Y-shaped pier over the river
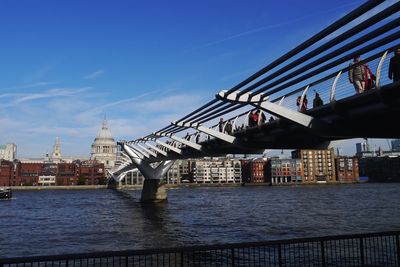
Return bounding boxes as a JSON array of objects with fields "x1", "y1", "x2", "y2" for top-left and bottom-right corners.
[{"x1": 109, "y1": 0, "x2": 400, "y2": 202}]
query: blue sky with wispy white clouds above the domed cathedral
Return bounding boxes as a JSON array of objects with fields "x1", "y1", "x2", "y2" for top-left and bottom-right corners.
[{"x1": 0, "y1": 0, "x2": 394, "y2": 157}]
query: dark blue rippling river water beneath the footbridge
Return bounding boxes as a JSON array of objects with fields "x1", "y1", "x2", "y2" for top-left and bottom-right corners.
[{"x1": 0, "y1": 184, "x2": 400, "y2": 258}]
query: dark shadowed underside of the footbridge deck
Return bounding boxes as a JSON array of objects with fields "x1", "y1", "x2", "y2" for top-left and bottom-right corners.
[{"x1": 146, "y1": 82, "x2": 400, "y2": 162}]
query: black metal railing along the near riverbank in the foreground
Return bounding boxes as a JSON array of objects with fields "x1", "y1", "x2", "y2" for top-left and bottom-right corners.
[{"x1": 0, "y1": 231, "x2": 400, "y2": 267}]
